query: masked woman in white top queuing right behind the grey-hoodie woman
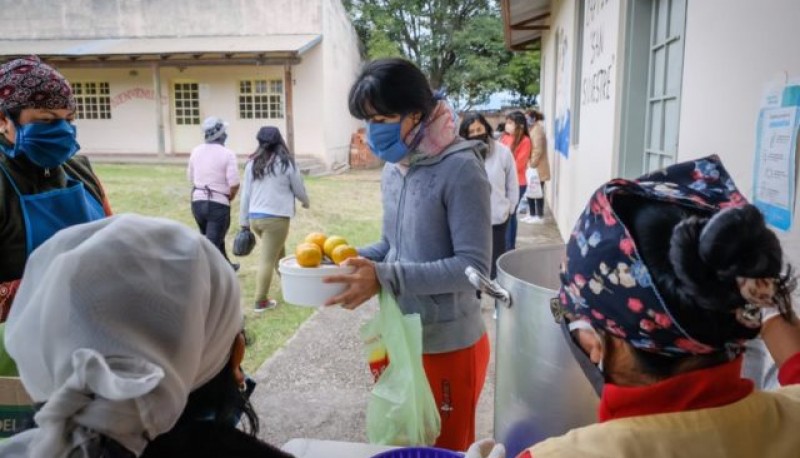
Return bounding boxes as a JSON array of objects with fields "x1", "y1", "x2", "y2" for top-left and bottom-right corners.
[{"x1": 458, "y1": 113, "x2": 519, "y2": 279}]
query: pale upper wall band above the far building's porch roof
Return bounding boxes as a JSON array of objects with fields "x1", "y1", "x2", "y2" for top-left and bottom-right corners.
[{"x1": 2, "y1": 0, "x2": 322, "y2": 39}]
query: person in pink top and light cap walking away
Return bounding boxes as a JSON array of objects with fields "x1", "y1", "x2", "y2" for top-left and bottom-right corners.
[{"x1": 186, "y1": 116, "x2": 239, "y2": 270}]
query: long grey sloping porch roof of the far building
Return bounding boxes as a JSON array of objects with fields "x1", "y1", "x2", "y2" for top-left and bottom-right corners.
[{"x1": 0, "y1": 34, "x2": 322, "y2": 67}]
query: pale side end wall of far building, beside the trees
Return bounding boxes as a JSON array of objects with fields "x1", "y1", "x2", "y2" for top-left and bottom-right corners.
[{"x1": 320, "y1": 0, "x2": 361, "y2": 166}]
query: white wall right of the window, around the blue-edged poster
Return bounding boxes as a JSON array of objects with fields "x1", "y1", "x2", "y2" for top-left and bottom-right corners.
[{"x1": 679, "y1": 0, "x2": 800, "y2": 264}]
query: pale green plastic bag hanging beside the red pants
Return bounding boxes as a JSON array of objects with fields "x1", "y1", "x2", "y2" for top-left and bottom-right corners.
[{"x1": 361, "y1": 290, "x2": 441, "y2": 445}]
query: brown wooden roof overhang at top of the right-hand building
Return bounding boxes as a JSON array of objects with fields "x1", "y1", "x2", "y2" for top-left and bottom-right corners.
[{"x1": 500, "y1": 0, "x2": 550, "y2": 51}]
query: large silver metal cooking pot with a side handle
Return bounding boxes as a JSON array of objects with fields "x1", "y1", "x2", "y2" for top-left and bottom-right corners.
[{"x1": 470, "y1": 245, "x2": 599, "y2": 457}]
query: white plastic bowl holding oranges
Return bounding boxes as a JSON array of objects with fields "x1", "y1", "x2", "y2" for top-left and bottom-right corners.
[{"x1": 278, "y1": 256, "x2": 355, "y2": 307}]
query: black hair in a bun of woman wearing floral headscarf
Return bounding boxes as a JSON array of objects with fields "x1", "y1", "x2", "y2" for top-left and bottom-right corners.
[{"x1": 613, "y1": 196, "x2": 796, "y2": 377}]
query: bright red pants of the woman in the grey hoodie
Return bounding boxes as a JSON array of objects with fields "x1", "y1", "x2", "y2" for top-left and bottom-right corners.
[{"x1": 422, "y1": 334, "x2": 490, "y2": 451}]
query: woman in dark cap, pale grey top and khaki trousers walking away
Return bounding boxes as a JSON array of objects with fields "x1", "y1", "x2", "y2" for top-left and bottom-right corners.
[{"x1": 239, "y1": 126, "x2": 310, "y2": 312}]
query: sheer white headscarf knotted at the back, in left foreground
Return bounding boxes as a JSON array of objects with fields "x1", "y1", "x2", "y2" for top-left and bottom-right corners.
[{"x1": 0, "y1": 215, "x2": 243, "y2": 458}]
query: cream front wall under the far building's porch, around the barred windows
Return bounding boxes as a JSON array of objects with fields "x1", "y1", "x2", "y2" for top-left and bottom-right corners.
[{"x1": 62, "y1": 64, "x2": 304, "y2": 155}]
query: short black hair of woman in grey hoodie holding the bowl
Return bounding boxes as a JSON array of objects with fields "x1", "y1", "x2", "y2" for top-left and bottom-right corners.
[{"x1": 348, "y1": 58, "x2": 436, "y2": 119}]
